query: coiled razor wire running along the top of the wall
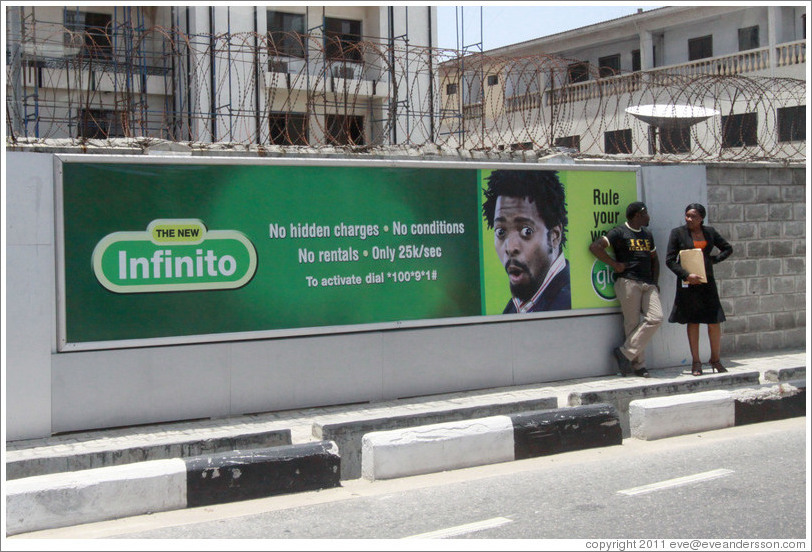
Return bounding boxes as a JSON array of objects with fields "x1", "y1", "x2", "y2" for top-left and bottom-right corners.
[{"x1": 6, "y1": 25, "x2": 806, "y2": 162}]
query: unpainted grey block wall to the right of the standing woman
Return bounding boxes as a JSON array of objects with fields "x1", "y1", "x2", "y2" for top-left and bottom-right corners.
[{"x1": 708, "y1": 164, "x2": 807, "y2": 352}]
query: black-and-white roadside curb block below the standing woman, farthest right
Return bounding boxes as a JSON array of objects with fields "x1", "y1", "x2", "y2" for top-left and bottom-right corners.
[{"x1": 629, "y1": 380, "x2": 806, "y2": 441}]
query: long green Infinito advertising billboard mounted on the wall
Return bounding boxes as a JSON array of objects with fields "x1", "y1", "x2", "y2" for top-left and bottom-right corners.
[{"x1": 59, "y1": 159, "x2": 637, "y2": 348}]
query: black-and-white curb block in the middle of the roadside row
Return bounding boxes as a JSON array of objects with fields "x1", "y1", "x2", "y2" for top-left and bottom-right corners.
[{"x1": 361, "y1": 404, "x2": 622, "y2": 480}]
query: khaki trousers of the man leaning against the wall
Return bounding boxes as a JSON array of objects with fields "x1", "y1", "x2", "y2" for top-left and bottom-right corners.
[{"x1": 615, "y1": 278, "x2": 663, "y2": 370}]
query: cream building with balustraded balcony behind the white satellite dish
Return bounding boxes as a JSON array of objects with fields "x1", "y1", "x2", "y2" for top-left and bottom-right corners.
[{"x1": 439, "y1": 5, "x2": 806, "y2": 158}]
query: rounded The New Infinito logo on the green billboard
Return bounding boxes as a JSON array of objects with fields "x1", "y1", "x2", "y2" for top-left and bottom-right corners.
[{"x1": 92, "y1": 219, "x2": 257, "y2": 293}]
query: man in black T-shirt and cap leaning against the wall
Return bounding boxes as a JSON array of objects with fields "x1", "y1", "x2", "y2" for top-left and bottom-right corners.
[{"x1": 589, "y1": 201, "x2": 663, "y2": 378}]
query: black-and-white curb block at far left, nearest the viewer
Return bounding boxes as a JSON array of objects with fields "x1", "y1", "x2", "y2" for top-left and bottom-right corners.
[{"x1": 6, "y1": 441, "x2": 341, "y2": 535}]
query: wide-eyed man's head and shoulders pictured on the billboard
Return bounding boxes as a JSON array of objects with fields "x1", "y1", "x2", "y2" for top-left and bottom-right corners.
[{"x1": 482, "y1": 170, "x2": 572, "y2": 314}]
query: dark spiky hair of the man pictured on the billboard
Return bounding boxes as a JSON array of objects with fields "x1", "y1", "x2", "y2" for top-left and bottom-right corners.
[{"x1": 482, "y1": 169, "x2": 567, "y2": 250}]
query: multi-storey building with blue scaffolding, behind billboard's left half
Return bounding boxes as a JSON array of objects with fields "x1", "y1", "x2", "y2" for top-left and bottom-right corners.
[{"x1": 7, "y1": 5, "x2": 437, "y2": 146}]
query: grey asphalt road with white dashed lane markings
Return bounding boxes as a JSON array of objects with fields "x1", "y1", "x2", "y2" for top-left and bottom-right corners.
[{"x1": 15, "y1": 418, "x2": 808, "y2": 549}]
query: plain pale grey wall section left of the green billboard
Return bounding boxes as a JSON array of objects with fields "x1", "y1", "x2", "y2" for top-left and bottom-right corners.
[{"x1": 3, "y1": 153, "x2": 56, "y2": 439}]
